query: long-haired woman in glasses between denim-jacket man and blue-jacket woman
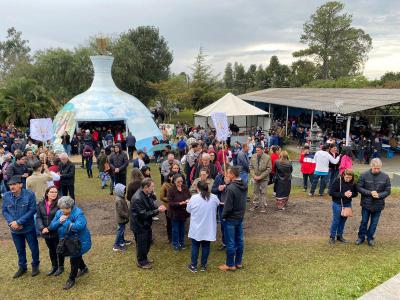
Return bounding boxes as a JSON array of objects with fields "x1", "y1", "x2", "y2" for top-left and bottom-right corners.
[{"x1": 36, "y1": 185, "x2": 64, "y2": 276}]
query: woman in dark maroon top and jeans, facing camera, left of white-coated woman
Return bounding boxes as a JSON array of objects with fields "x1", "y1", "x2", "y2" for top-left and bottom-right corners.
[{"x1": 167, "y1": 173, "x2": 190, "y2": 251}]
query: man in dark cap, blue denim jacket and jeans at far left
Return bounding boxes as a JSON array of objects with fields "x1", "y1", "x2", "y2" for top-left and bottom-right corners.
[{"x1": 2, "y1": 175, "x2": 40, "y2": 278}]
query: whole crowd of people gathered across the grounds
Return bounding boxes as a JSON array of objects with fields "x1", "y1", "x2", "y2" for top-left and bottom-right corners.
[{"x1": 0, "y1": 119, "x2": 391, "y2": 289}]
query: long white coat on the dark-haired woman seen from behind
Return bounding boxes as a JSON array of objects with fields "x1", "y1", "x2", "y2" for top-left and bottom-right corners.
[{"x1": 186, "y1": 194, "x2": 219, "y2": 242}]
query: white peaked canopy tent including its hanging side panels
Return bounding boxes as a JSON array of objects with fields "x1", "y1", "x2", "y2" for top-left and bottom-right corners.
[{"x1": 194, "y1": 93, "x2": 270, "y2": 130}]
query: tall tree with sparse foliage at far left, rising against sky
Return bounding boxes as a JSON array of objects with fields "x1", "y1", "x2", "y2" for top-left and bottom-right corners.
[{"x1": 0, "y1": 27, "x2": 31, "y2": 82}]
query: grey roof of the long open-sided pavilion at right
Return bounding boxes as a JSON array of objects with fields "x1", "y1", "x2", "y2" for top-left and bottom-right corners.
[{"x1": 238, "y1": 88, "x2": 400, "y2": 114}]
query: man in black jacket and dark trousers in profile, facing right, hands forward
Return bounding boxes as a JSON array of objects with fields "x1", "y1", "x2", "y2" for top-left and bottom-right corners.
[{"x1": 131, "y1": 178, "x2": 166, "y2": 269}]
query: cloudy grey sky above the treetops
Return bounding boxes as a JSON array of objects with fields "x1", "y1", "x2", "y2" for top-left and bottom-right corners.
[{"x1": 0, "y1": 0, "x2": 400, "y2": 78}]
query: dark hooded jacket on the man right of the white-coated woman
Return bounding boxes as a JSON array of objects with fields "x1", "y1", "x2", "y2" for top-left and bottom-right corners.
[{"x1": 222, "y1": 179, "x2": 247, "y2": 220}]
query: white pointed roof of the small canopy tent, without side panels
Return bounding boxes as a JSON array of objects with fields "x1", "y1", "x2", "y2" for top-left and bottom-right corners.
[{"x1": 194, "y1": 93, "x2": 269, "y2": 117}]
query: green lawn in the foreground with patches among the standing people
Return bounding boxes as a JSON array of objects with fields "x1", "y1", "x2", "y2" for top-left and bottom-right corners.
[{"x1": 0, "y1": 165, "x2": 400, "y2": 299}]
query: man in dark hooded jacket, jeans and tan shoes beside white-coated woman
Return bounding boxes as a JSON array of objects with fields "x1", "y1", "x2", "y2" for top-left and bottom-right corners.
[{"x1": 218, "y1": 167, "x2": 247, "y2": 271}]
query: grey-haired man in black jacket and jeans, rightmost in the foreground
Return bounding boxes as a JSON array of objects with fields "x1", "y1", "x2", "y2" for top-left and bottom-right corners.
[{"x1": 356, "y1": 158, "x2": 391, "y2": 246}]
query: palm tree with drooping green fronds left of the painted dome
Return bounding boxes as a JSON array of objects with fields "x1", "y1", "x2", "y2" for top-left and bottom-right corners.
[{"x1": 0, "y1": 77, "x2": 58, "y2": 126}]
